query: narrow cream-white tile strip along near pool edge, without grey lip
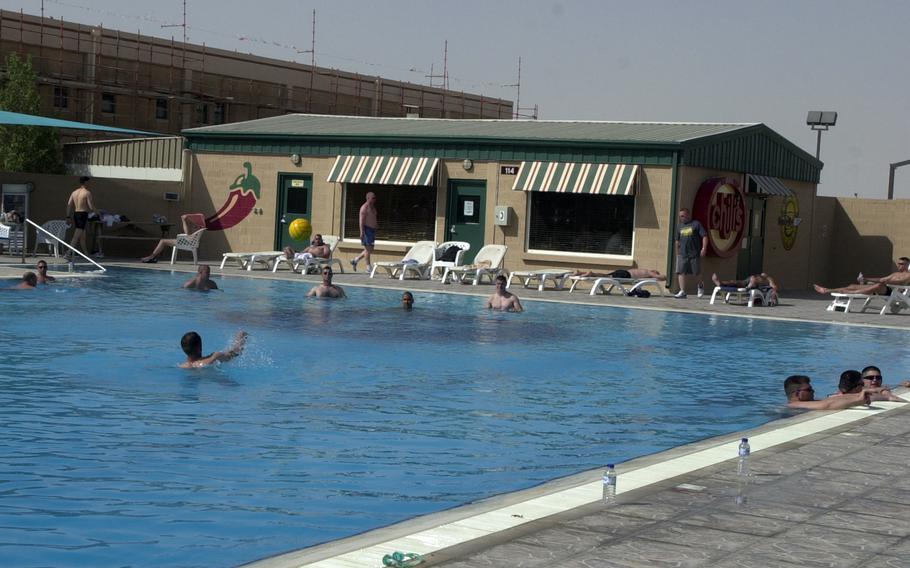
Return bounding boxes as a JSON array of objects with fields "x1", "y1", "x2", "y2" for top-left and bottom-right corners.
[{"x1": 255, "y1": 402, "x2": 906, "y2": 568}]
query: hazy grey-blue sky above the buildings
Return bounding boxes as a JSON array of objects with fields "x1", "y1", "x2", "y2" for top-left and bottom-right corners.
[{"x1": 0, "y1": 0, "x2": 910, "y2": 199}]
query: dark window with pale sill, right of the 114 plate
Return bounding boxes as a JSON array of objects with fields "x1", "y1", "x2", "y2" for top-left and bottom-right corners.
[{"x1": 528, "y1": 191, "x2": 635, "y2": 256}]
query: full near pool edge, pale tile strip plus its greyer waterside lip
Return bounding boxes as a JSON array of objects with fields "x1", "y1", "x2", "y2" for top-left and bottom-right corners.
[{"x1": 243, "y1": 402, "x2": 908, "y2": 568}]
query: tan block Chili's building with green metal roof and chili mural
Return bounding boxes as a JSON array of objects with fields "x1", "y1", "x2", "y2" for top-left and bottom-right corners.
[{"x1": 183, "y1": 114, "x2": 822, "y2": 288}]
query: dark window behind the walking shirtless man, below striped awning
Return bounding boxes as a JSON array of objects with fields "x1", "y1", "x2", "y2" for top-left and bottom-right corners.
[{"x1": 344, "y1": 183, "x2": 436, "y2": 242}]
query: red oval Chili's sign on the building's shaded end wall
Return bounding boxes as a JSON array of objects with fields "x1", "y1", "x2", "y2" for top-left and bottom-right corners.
[{"x1": 692, "y1": 178, "x2": 746, "y2": 258}]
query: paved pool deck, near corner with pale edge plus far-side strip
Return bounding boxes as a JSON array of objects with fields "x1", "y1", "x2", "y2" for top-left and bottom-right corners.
[{"x1": 0, "y1": 255, "x2": 910, "y2": 568}]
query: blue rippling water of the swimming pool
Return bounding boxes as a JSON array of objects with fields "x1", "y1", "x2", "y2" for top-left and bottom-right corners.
[{"x1": 0, "y1": 270, "x2": 908, "y2": 567}]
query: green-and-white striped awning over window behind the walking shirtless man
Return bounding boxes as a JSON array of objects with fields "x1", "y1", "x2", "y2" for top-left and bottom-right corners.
[{"x1": 328, "y1": 156, "x2": 439, "y2": 185}]
